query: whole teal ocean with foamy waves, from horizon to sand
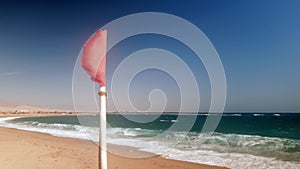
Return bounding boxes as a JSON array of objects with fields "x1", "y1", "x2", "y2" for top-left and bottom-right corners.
[{"x1": 0, "y1": 113, "x2": 300, "y2": 169}]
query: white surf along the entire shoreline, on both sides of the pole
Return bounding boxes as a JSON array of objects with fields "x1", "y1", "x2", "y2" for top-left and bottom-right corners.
[{"x1": 0, "y1": 117, "x2": 300, "y2": 169}]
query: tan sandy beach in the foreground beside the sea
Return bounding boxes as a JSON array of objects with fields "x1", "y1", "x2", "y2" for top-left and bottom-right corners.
[{"x1": 0, "y1": 119, "x2": 226, "y2": 169}]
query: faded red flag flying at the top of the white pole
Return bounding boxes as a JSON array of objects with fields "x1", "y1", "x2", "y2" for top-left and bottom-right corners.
[{"x1": 81, "y1": 30, "x2": 107, "y2": 86}]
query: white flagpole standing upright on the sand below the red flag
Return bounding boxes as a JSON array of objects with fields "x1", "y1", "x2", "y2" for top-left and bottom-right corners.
[{"x1": 99, "y1": 86, "x2": 107, "y2": 169}]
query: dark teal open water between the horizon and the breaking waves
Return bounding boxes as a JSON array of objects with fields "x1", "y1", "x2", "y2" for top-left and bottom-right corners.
[{"x1": 13, "y1": 113, "x2": 300, "y2": 139}]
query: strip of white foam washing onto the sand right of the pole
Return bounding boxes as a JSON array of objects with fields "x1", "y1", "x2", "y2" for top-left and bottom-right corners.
[{"x1": 109, "y1": 138, "x2": 300, "y2": 169}]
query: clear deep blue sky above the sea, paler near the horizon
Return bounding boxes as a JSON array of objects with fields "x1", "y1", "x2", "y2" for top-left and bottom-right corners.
[{"x1": 0, "y1": 0, "x2": 300, "y2": 111}]
